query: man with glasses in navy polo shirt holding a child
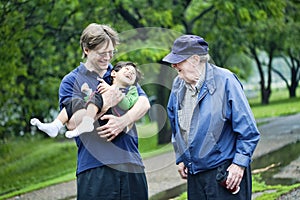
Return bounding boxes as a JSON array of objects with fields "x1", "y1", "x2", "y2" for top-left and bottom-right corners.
[{"x1": 37, "y1": 23, "x2": 150, "y2": 200}]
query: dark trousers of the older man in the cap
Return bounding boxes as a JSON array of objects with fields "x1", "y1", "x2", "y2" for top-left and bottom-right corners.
[{"x1": 187, "y1": 162, "x2": 252, "y2": 200}]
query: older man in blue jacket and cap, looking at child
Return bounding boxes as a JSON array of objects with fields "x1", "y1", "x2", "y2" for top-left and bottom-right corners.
[{"x1": 163, "y1": 35, "x2": 259, "y2": 200}]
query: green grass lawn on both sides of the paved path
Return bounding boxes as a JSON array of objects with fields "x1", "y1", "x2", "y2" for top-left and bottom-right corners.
[{"x1": 0, "y1": 89, "x2": 300, "y2": 199}]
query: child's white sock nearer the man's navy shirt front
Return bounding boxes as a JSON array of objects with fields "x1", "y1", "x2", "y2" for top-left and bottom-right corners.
[{"x1": 65, "y1": 116, "x2": 94, "y2": 138}]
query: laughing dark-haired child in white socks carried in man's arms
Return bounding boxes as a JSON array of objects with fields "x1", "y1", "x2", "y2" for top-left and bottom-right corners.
[{"x1": 30, "y1": 62, "x2": 141, "y2": 138}]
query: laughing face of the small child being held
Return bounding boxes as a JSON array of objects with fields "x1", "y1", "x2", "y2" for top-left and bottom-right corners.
[{"x1": 111, "y1": 65, "x2": 136, "y2": 87}]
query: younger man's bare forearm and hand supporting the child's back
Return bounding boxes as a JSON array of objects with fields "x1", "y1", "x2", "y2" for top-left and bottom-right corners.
[{"x1": 97, "y1": 96, "x2": 150, "y2": 141}]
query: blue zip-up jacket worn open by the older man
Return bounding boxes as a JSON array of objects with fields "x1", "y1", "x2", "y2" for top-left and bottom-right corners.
[{"x1": 168, "y1": 63, "x2": 260, "y2": 174}]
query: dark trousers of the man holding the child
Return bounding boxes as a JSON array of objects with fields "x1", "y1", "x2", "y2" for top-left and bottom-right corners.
[{"x1": 77, "y1": 164, "x2": 148, "y2": 200}]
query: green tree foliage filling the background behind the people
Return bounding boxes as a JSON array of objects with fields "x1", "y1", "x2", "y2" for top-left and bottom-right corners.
[{"x1": 0, "y1": 0, "x2": 300, "y2": 143}]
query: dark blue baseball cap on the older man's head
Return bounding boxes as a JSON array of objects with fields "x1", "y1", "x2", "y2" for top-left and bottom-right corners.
[{"x1": 163, "y1": 35, "x2": 208, "y2": 64}]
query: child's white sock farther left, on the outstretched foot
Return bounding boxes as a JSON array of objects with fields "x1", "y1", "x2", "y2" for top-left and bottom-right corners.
[{"x1": 30, "y1": 118, "x2": 64, "y2": 137}]
